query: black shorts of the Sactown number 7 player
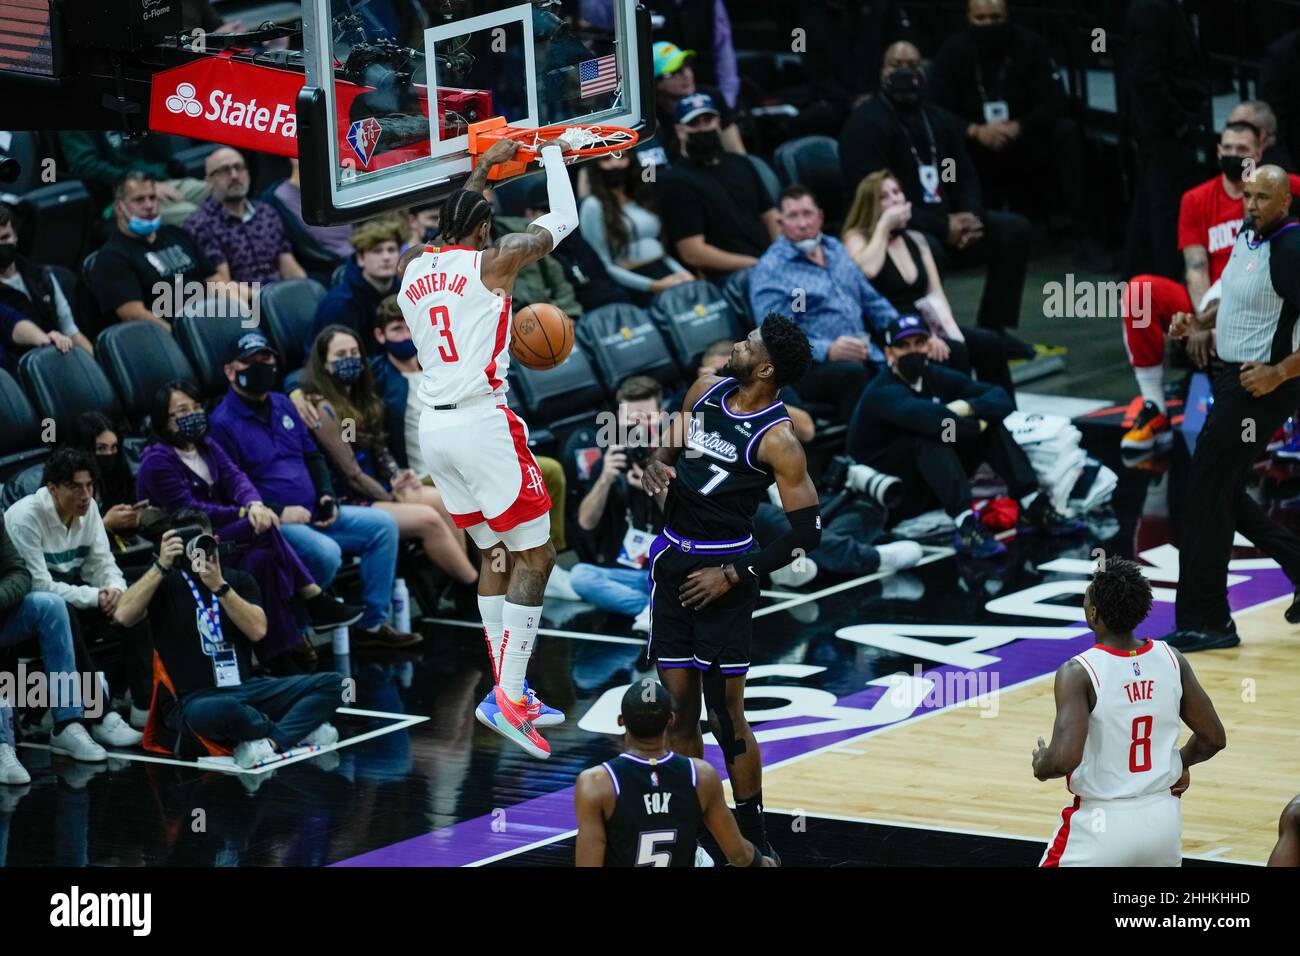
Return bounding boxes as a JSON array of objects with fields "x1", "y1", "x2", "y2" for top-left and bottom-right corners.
[{"x1": 646, "y1": 535, "x2": 759, "y2": 676}]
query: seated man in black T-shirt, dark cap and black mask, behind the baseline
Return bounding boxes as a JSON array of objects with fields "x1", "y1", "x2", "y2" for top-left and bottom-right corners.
[{"x1": 659, "y1": 92, "x2": 780, "y2": 281}]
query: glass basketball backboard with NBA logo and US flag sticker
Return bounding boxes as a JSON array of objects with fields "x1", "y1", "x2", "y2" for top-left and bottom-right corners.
[{"x1": 298, "y1": 0, "x2": 654, "y2": 222}]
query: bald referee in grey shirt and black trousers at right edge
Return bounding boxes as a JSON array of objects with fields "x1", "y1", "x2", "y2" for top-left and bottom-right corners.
[{"x1": 1165, "y1": 165, "x2": 1300, "y2": 653}]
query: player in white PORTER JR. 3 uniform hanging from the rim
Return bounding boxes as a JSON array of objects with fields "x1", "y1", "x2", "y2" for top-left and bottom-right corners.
[{"x1": 398, "y1": 139, "x2": 577, "y2": 758}]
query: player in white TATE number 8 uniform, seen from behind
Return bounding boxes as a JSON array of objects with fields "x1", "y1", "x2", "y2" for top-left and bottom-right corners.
[{"x1": 1034, "y1": 558, "x2": 1226, "y2": 866}]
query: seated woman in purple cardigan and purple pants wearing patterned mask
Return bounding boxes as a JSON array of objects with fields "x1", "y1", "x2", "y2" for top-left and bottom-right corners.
[{"x1": 135, "y1": 381, "x2": 361, "y2": 670}]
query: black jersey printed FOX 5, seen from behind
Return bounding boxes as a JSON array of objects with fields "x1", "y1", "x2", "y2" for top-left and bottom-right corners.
[{"x1": 601, "y1": 750, "x2": 703, "y2": 866}]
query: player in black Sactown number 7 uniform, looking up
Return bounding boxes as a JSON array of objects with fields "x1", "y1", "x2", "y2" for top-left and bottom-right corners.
[{"x1": 641, "y1": 315, "x2": 822, "y2": 856}]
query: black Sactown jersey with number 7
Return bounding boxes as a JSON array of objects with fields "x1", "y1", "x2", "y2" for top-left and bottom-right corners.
[{"x1": 663, "y1": 378, "x2": 790, "y2": 541}]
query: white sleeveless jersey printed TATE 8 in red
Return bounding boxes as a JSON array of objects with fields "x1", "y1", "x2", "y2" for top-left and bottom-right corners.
[{"x1": 1067, "y1": 640, "x2": 1183, "y2": 800}]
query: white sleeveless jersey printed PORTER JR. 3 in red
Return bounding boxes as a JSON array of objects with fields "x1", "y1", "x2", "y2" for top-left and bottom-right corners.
[{"x1": 398, "y1": 246, "x2": 510, "y2": 407}]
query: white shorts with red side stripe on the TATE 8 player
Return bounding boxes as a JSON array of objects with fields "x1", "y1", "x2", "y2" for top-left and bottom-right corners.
[{"x1": 1039, "y1": 791, "x2": 1183, "y2": 866}]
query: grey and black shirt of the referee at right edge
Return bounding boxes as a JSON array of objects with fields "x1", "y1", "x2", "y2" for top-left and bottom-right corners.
[{"x1": 1214, "y1": 219, "x2": 1300, "y2": 365}]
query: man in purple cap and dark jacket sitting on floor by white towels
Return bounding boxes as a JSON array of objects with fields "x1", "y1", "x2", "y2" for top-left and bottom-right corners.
[{"x1": 846, "y1": 315, "x2": 1083, "y2": 558}]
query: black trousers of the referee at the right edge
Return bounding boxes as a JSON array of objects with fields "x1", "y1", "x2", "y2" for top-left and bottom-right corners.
[{"x1": 1175, "y1": 363, "x2": 1300, "y2": 631}]
